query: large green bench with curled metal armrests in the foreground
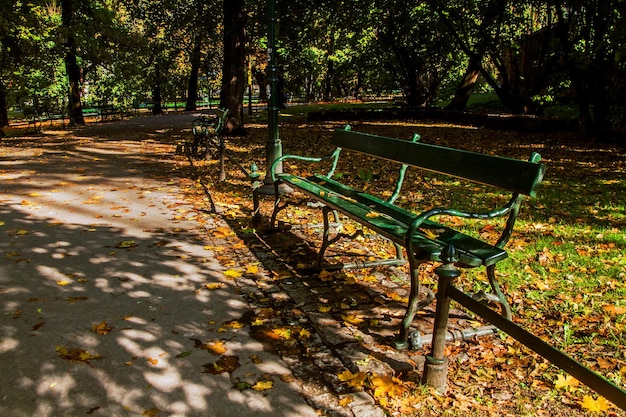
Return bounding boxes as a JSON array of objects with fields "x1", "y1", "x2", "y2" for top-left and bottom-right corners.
[{"x1": 255, "y1": 126, "x2": 545, "y2": 349}]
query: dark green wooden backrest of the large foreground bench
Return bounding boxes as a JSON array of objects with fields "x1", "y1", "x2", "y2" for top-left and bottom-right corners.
[{"x1": 332, "y1": 126, "x2": 545, "y2": 196}]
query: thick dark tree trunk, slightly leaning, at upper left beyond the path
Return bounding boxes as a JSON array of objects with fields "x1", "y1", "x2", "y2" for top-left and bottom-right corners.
[{"x1": 61, "y1": 0, "x2": 85, "y2": 125}]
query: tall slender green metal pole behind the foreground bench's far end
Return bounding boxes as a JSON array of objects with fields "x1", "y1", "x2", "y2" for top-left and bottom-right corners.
[{"x1": 259, "y1": 0, "x2": 283, "y2": 194}]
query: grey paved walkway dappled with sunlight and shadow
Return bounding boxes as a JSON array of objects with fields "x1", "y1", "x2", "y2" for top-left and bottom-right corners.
[{"x1": 0, "y1": 118, "x2": 317, "y2": 417}]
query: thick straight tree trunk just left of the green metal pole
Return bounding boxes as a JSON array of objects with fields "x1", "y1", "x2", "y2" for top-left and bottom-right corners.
[{"x1": 220, "y1": 0, "x2": 246, "y2": 134}]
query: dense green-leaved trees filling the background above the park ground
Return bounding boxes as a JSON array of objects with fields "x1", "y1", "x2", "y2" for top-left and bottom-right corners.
[{"x1": 0, "y1": 0, "x2": 626, "y2": 140}]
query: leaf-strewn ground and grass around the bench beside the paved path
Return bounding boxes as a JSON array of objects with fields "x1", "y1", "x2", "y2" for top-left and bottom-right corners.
[{"x1": 2, "y1": 109, "x2": 626, "y2": 416}]
